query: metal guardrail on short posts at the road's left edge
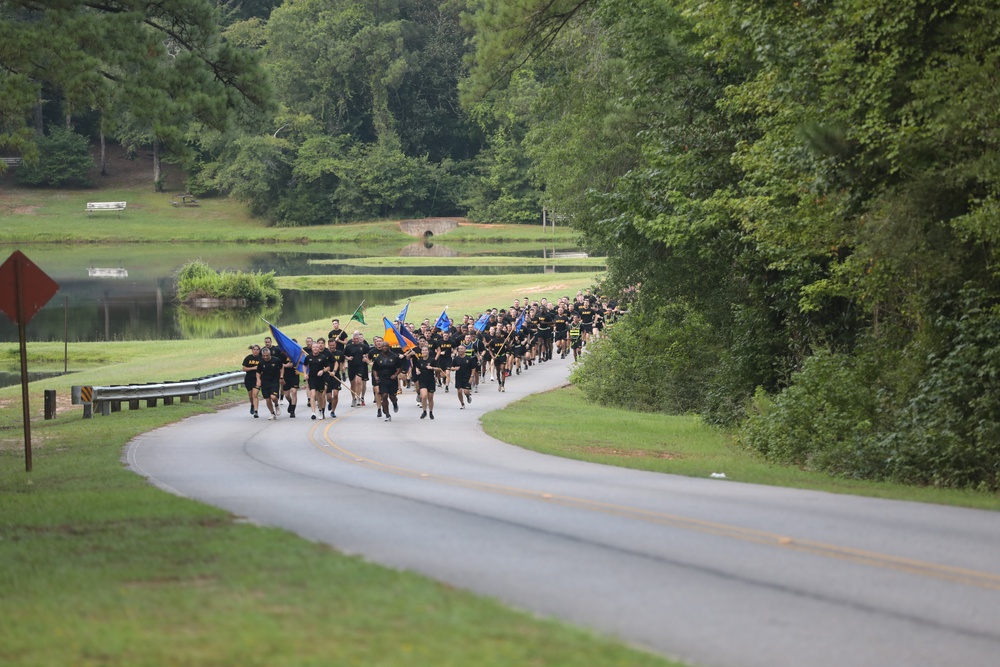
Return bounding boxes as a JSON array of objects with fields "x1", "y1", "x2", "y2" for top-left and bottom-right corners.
[{"x1": 72, "y1": 371, "x2": 246, "y2": 419}]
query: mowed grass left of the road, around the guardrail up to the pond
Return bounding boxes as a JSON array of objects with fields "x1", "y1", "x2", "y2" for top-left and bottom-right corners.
[{"x1": 0, "y1": 276, "x2": 673, "y2": 667}]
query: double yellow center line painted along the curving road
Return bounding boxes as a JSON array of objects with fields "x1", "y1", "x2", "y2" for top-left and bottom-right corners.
[{"x1": 309, "y1": 418, "x2": 1000, "y2": 591}]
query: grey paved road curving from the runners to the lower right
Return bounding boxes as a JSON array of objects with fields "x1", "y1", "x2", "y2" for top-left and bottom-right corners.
[{"x1": 127, "y1": 362, "x2": 1000, "y2": 667}]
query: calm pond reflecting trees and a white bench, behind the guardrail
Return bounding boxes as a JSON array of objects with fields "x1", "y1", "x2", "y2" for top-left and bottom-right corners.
[{"x1": 0, "y1": 244, "x2": 593, "y2": 342}]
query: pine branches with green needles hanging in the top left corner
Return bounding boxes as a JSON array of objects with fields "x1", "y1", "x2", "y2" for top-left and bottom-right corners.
[{"x1": 0, "y1": 0, "x2": 270, "y2": 157}]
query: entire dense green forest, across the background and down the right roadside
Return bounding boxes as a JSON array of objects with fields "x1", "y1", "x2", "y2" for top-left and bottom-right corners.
[{"x1": 0, "y1": 0, "x2": 1000, "y2": 490}]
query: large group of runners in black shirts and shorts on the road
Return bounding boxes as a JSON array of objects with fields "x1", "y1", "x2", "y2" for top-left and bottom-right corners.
[{"x1": 243, "y1": 290, "x2": 618, "y2": 422}]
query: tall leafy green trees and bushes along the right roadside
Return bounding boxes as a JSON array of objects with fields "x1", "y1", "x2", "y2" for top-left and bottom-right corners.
[{"x1": 464, "y1": 0, "x2": 1000, "y2": 490}]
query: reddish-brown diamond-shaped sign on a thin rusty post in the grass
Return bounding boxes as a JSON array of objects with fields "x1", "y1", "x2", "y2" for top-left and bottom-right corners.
[{"x1": 0, "y1": 250, "x2": 59, "y2": 472}]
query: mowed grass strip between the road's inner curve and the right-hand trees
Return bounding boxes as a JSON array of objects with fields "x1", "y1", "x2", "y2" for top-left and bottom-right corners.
[{"x1": 482, "y1": 386, "x2": 1000, "y2": 510}]
